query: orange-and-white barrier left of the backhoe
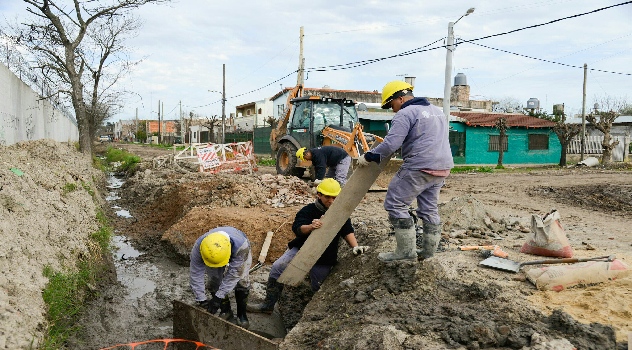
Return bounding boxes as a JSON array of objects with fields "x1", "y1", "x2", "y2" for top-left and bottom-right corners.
[{"x1": 196, "y1": 141, "x2": 257, "y2": 174}]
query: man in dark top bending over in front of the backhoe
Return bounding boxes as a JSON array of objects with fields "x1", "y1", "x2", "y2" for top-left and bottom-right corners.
[{"x1": 296, "y1": 146, "x2": 351, "y2": 186}]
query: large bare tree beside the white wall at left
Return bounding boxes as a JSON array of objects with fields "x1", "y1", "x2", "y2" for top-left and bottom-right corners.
[{"x1": 6, "y1": 0, "x2": 167, "y2": 153}]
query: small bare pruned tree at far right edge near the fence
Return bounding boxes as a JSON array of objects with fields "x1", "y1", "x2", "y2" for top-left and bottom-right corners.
[{"x1": 586, "y1": 97, "x2": 628, "y2": 164}]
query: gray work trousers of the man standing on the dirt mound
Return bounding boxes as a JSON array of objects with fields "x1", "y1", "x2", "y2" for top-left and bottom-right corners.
[{"x1": 384, "y1": 168, "x2": 445, "y2": 225}]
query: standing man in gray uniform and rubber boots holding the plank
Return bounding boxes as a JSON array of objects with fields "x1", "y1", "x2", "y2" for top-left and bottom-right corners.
[{"x1": 358, "y1": 80, "x2": 454, "y2": 261}]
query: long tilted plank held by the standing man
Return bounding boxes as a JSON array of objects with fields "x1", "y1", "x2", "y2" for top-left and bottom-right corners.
[{"x1": 278, "y1": 157, "x2": 390, "y2": 286}]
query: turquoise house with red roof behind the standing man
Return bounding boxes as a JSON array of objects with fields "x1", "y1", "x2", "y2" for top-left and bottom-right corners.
[{"x1": 450, "y1": 111, "x2": 562, "y2": 165}]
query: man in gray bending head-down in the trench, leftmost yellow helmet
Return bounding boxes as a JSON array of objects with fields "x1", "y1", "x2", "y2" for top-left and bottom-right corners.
[{"x1": 189, "y1": 226, "x2": 252, "y2": 329}]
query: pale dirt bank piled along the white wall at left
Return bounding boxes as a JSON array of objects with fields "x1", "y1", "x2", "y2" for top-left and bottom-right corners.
[{"x1": 0, "y1": 140, "x2": 103, "y2": 349}]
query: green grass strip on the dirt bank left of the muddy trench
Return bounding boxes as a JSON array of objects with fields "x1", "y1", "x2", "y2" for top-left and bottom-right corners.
[{"x1": 39, "y1": 212, "x2": 113, "y2": 350}]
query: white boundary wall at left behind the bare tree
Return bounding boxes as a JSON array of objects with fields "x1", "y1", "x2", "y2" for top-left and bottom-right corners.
[{"x1": 0, "y1": 64, "x2": 79, "y2": 146}]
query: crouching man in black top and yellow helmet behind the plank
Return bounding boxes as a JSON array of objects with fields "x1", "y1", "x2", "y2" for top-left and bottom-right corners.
[{"x1": 247, "y1": 179, "x2": 369, "y2": 314}]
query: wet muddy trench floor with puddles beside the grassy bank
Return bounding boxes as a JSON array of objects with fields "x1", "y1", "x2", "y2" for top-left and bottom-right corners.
[{"x1": 68, "y1": 174, "x2": 288, "y2": 350}]
